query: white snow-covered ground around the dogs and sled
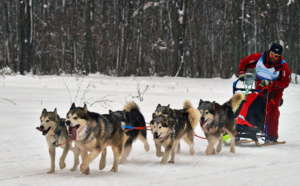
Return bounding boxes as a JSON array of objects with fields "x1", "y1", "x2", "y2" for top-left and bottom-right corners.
[{"x1": 0, "y1": 74, "x2": 300, "y2": 186}]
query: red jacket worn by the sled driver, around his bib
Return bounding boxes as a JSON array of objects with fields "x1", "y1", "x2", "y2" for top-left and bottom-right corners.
[{"x1": 239, "y1": 51, "x2": 291, "y2": 92}]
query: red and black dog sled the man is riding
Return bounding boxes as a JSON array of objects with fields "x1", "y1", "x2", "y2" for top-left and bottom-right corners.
[{"x1": 230, "y1": 73, "x2": 285, "y2": 146}]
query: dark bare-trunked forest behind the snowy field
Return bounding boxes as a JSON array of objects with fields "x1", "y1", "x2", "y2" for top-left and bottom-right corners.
[{"x1": 0, "y1": 0, "x2": 300, "y2": 78}]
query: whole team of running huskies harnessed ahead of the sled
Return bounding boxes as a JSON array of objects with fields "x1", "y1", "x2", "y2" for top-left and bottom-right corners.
[{"x1": 37, "y1": 93, "x2": 244, "y2": 175}]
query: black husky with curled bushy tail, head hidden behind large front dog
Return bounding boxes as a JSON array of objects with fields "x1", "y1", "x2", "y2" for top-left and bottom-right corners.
[{"x1": 109, "y1": 102, "x2": 150, "y2": 163}]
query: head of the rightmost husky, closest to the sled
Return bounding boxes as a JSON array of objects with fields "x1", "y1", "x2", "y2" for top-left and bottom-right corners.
[{"x1": 198, "y1": 99, "x2": 215, "y2": 128}]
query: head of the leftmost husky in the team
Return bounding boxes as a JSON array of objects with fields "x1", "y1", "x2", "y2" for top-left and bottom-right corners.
[{"x1": 37, "y1": 108, "x2": 60, "y2": 135}]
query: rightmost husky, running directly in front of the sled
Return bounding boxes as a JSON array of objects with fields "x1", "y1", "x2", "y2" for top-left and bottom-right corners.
[{"x1": 198, "y1": 93, "x2": 244, "y2": 155}]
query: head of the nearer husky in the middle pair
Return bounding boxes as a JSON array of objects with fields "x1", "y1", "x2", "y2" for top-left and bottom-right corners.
[{"x1": 150, "y1": 115, "x2": 175, "y2": 139}]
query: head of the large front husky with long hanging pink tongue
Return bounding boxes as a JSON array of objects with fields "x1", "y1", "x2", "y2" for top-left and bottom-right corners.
[{"x1": 66, "y1": 103, "x2": 88, "y2": 141}]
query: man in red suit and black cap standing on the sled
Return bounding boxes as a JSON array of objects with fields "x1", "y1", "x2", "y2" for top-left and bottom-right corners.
[{"x1": 239, "y1": 43, "x2": 291, "y2": 142}]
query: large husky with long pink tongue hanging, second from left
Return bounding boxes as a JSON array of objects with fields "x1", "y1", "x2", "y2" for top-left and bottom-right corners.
[{"x1": 66, "y1": 103, "x2": 123, "y2": 175}]
